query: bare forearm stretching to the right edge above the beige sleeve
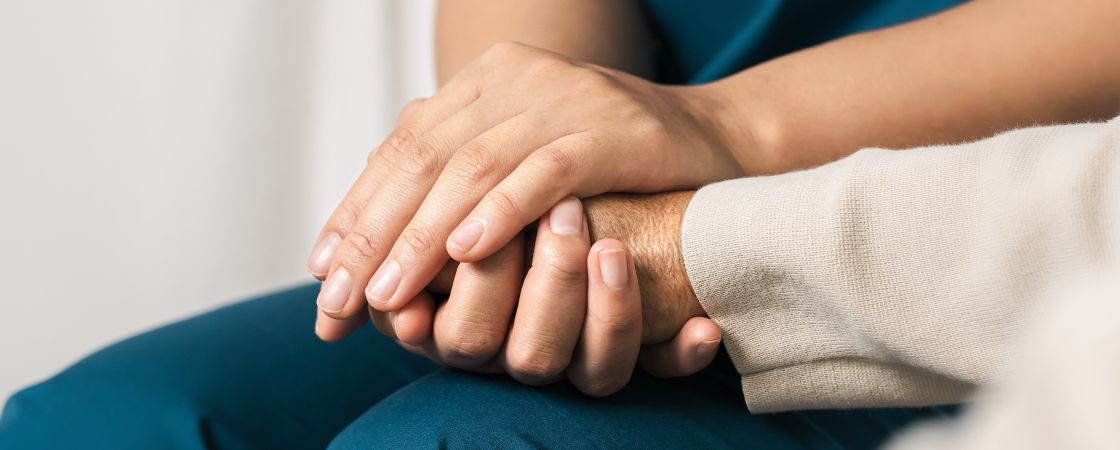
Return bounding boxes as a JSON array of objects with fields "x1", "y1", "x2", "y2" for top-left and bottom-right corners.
[{"x1": 694, "y1": 0, "x2": 1120, "y2": 175}]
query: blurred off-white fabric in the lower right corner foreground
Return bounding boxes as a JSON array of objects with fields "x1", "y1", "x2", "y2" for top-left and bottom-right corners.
[{"x1": 887, "y1": 268, "x2": 1120, "y2": 450}]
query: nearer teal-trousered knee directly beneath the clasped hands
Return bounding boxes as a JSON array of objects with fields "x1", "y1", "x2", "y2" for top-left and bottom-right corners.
[{"x1": 330, "y1": 355, "x2": 931, "y2": 450}]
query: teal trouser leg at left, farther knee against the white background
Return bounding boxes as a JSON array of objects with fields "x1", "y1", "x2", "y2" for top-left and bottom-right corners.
[{"x1": 0, "y1": 284, "x2": 435, "y2": 449}]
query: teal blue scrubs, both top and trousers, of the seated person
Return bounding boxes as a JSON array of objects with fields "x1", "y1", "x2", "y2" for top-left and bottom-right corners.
[{"x1": 0, "y1": 0, "x2": 955, "y2": 449}]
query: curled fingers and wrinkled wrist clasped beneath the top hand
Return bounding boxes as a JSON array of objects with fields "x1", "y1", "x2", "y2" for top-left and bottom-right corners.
[{"x1": 371, "y1": 193, "x2": 720, "y2": 395}]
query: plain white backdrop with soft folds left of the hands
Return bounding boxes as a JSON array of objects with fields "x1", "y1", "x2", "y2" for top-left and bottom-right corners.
[{"x1": 0, "y1": 0, "x2": 435, "y2": 400}]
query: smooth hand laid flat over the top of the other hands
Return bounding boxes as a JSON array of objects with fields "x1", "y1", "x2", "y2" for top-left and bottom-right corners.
[{"x1": 308, "y1": 44, "x2": 741, "y2": 335}]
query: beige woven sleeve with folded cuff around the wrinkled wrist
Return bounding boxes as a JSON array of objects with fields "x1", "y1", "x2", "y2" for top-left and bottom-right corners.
[{"x1": 682, "y1": 118, "x2": 1120, "y2": 412}]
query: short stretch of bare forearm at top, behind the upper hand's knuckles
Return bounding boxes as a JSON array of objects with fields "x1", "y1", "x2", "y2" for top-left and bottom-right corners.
[{"x1": 436, "y1": 0, "x2": 653, "y2": 85}]
